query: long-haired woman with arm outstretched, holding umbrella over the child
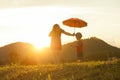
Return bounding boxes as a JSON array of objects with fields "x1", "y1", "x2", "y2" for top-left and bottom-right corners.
[{"x1": 49, "y1": 24, "x2": 75, "y2": 63}]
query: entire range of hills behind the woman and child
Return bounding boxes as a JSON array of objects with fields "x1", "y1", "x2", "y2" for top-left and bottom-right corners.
[{"x1": 0, "y1": 37, "x2": 120, "y2": 64}]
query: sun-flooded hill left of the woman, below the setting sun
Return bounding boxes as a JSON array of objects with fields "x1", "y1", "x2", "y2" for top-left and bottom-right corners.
[{"x1": 0, "y1": 42, "x2": 50, "y2": 65}]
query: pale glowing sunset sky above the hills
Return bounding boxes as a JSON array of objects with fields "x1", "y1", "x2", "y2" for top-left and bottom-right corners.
[{"x1": 0, "y1": 0, "x2": 120, "y2": 47}]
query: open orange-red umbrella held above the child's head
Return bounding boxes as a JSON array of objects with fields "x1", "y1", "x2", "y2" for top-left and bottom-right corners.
[{"x1": 63, "y1": 18, "x2": 87, "y2": 32}]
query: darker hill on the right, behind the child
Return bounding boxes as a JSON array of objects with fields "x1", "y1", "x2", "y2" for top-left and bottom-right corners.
[{"x1": 62, "y1": 37, "x2": 120, "y2": 60}]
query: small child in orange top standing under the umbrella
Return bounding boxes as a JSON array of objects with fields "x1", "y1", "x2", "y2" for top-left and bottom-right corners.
[{"x1": 75, "y1": 32, "x2": 83, "y2": 61}]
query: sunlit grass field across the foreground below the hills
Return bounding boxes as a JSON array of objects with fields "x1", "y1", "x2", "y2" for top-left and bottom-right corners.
[{"x1": 0, "y1": 59, "x2": 120, "y2": 80}]
